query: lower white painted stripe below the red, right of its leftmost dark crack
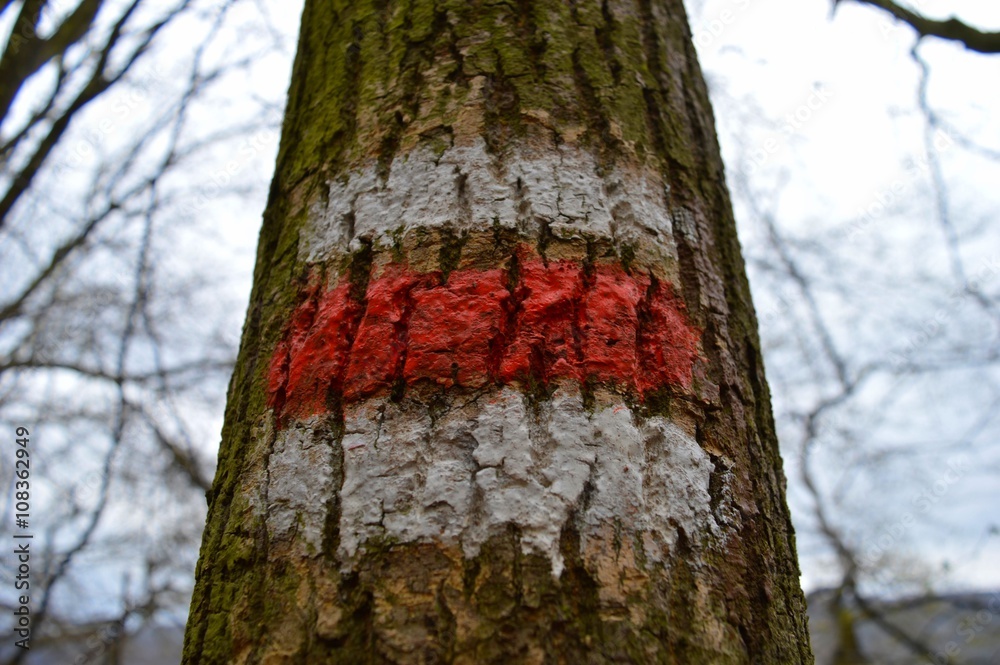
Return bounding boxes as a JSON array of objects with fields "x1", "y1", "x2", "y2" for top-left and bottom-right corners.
[{"x1": 330, "y1": 384, "x2": 722, "y2": 576}]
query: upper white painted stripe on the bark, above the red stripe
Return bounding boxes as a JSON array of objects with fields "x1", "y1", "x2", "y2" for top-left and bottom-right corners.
[{"x1": 299, "y1": 138, "x2": 677, "y2": 265}]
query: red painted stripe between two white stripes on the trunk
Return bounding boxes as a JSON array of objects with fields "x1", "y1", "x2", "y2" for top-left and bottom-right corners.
[{"x1": 268, "y1": 259, "x2": 699, "y2": 417}]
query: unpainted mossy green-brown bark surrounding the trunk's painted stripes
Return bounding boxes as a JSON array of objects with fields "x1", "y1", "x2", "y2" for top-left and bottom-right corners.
[{"x1": 184, "y1": 0, "x2": 811, "y2": 665}]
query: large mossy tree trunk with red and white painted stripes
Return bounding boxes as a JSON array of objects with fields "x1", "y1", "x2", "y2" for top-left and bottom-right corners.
[{"x1": 184, "y1": 0, "x2": 812, "y2": 665}]
